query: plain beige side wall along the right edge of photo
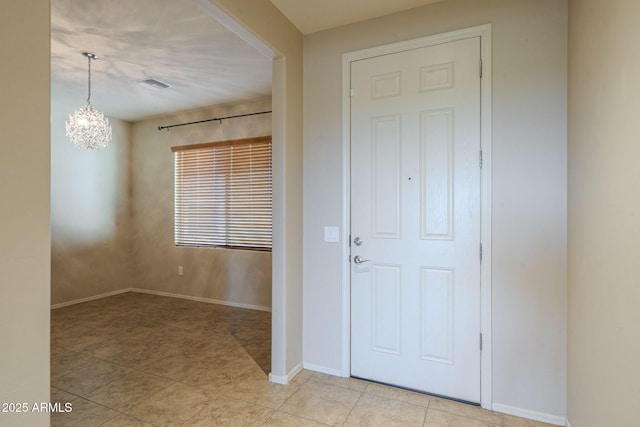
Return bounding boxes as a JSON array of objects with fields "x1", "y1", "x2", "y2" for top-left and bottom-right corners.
[{"x1": 568, "y1": 0, "x2": 640, "y2": 427}]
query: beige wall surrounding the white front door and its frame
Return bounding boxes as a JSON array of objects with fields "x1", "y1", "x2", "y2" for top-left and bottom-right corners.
[{"x1": 304, "y1": 0, "x2": 567, "y2": 422}]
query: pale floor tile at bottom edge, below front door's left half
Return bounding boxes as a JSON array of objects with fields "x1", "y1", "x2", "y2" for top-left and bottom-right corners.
[{"x1": 344, "y1": 394, "x2": 427, "y2": 427}]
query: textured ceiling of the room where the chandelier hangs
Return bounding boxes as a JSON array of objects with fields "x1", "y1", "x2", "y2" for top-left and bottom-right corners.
[{"x1": 51, "y1": 0, "x2": 271, "y2": 121}]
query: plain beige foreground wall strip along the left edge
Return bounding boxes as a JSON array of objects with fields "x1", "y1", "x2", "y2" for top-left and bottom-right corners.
[{"x1": 0, "y1": 0, "x2": 51, "y2": 426}]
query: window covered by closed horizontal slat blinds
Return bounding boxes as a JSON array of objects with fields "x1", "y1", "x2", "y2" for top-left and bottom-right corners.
[{"x1": 171, "y1": 136, "x2": 272, "y2": 251}]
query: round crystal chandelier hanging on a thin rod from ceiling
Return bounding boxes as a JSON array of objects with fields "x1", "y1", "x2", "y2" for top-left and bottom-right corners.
[{"x1": 65, "y1": 52, "x2": 111, "y2": 150}]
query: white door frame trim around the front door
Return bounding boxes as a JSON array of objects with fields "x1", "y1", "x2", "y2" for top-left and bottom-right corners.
[{"x1": 341, "y1": 24, "x2": 492, "y2": 409}]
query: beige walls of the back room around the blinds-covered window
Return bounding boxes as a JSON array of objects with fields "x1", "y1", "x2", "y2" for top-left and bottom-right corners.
[{"x1": 51, "y1": 99, "x2": 271, "y2": 309}]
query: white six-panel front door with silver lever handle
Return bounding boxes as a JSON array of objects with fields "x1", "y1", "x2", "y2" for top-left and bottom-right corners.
[{"x1": 351, "y1": 37, "x2": 480, "y2": 402}]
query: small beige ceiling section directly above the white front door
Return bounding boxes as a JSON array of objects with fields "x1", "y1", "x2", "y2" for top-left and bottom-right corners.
[{"x1": 271, "y1": 0, "x2": 442, "y2": 34}]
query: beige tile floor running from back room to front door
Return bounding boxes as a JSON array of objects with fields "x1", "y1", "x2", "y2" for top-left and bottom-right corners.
[{"x1": 51, "y1": 292, "x2": 548, "y2": 427}]
